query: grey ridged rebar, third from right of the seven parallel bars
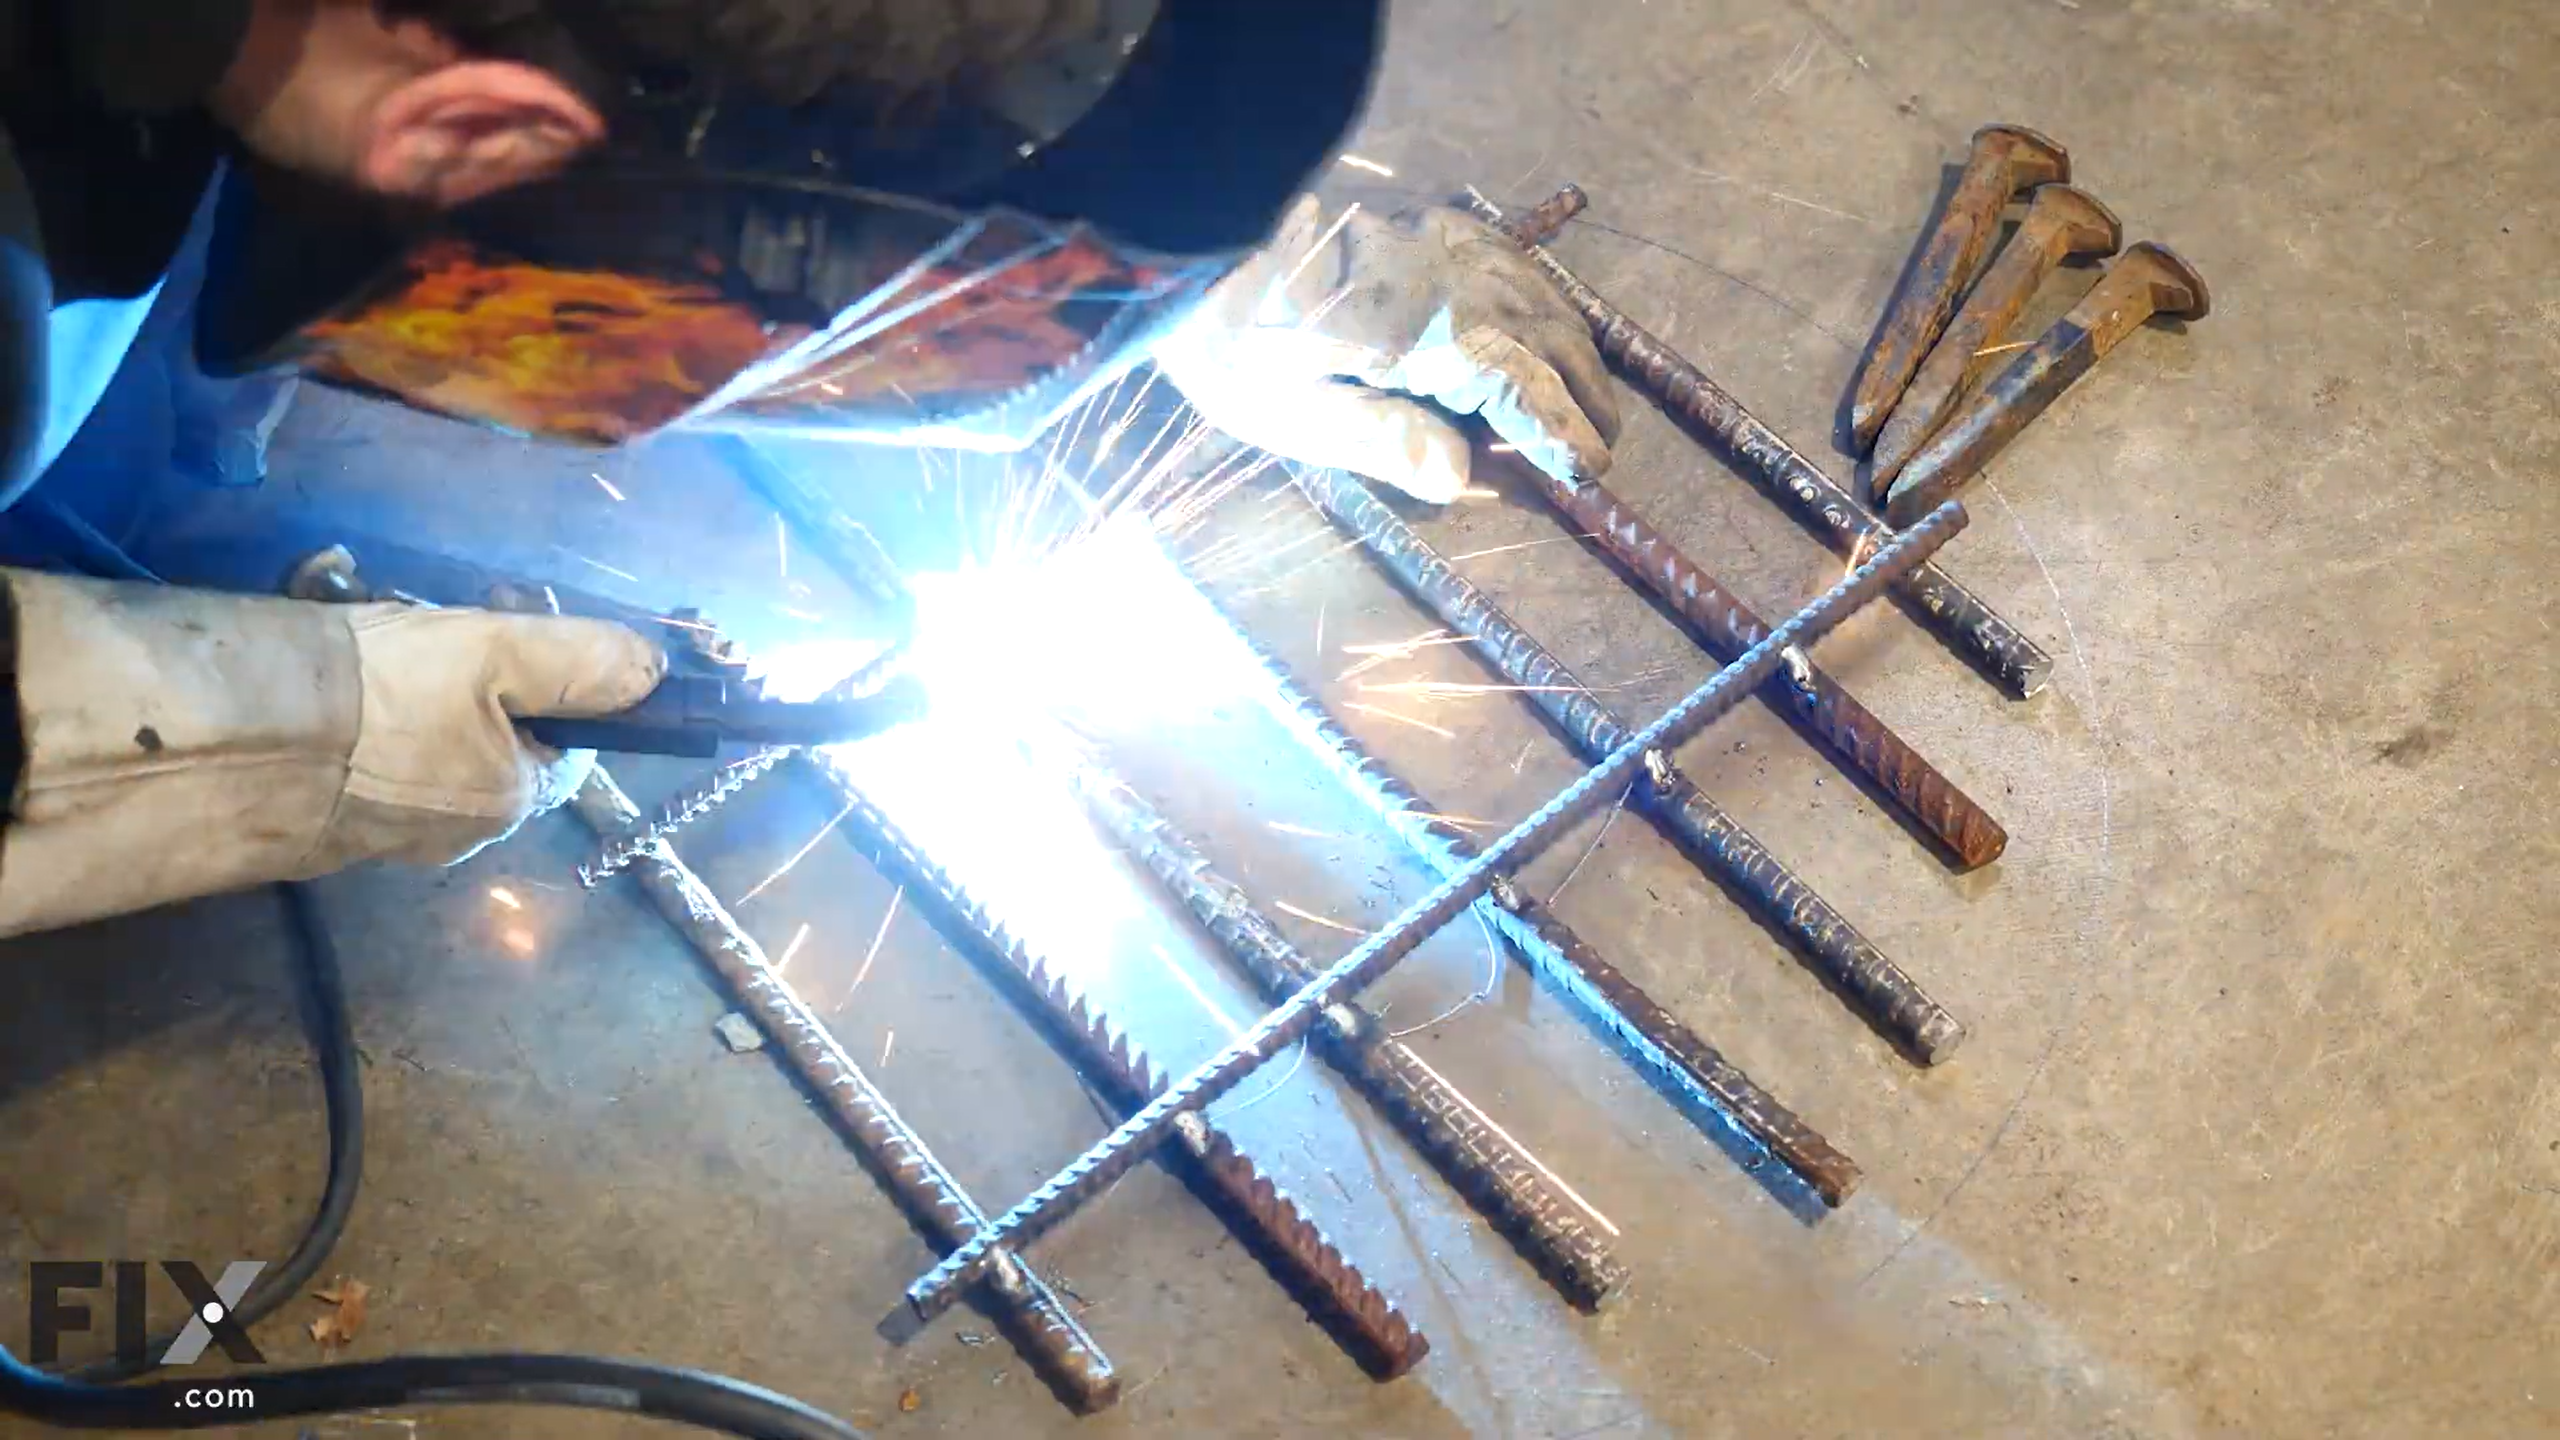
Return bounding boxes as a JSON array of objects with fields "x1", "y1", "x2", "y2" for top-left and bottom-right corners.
[{"x1": 1295, "y1": 469, "x2": 1964, "y2": 1063}]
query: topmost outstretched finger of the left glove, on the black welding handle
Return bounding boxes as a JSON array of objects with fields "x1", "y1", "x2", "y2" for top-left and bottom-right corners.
[{"x1": 356, "y1": 607, "x2": 666, "y2": 720}]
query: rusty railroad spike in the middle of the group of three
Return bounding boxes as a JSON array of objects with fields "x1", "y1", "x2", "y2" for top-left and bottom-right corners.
[{"x1": 1869, "y1": 184, "x2": 2125, "y2": 502}]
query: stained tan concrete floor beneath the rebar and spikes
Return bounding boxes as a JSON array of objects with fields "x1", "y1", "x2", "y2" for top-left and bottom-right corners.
[{"x1": 0, "y1": 0, "x2": 2560, "y2": 1437}]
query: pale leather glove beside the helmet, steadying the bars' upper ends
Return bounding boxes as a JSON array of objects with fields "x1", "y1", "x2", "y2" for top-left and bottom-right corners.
[{"x1": 1155, "y1": 195, "x2": 1618, "y2": 502}]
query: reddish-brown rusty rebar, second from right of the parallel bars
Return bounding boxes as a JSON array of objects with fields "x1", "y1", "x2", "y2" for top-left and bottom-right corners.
[{"x1": 1539, "y1": 458, "x2": 2010, "y2": 871}]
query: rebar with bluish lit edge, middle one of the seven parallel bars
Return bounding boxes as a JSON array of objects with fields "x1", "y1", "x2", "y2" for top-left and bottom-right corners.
[{"x1": 1177, "y1": 604, "x2": 1859, "y2": 1207}]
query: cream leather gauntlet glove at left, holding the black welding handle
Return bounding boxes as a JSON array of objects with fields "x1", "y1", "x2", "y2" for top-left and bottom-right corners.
[{"x1": 0, "y1": 571, "x2": 666, "y2": 935}]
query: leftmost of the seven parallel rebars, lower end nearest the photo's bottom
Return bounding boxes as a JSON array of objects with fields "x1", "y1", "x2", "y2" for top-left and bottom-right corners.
[{"x1": 571, "y1": 766, "x2": 1119, "y2": 1414}]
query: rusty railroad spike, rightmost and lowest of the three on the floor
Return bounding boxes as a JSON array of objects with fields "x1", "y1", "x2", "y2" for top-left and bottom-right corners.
[{"x1": 1884, "y1": 241, "x2": 2212, "y2": 520}]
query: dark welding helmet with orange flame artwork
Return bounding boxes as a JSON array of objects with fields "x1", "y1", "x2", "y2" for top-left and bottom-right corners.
[{"x1": 197, "y1": 0, "x2": 1382, "y2": 448}]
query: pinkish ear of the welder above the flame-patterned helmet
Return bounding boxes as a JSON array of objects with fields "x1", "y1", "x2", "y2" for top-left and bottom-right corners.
[{"x1": 358, "y1": 59, "x2": 604, "y2": 205}]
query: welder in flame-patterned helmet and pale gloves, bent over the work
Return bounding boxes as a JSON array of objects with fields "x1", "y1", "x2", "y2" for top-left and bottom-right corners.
[{"x1": 0, "y1": 0, "x2": 1615, "y2": 933}]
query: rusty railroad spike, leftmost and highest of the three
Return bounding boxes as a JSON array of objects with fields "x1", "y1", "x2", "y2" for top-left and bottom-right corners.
[{"x1": 1848, "y1": 126, "x2": 2071, "y2": 454}]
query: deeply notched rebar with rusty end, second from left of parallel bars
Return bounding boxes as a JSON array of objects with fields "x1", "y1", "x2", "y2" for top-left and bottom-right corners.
[{"x1": 809, "y1": 751, "x2": 1431, "y2": 1379}]
